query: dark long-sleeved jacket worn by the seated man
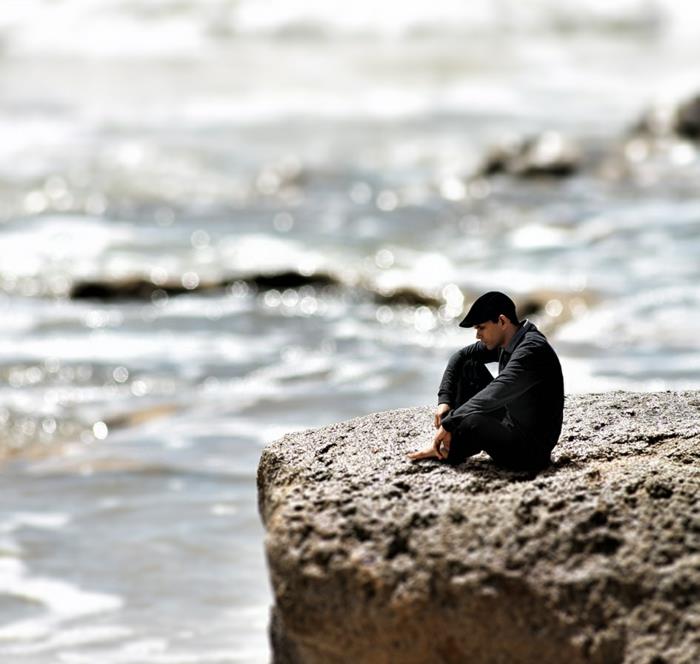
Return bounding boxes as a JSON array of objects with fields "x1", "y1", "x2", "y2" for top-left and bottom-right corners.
[{"x1": 438, "y1": 320, "x2": 564, "y2": 451}]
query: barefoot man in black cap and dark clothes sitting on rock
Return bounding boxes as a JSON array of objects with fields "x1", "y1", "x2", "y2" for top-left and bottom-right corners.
[{"x1": 408, "y1": 291, "x2": 564, "y2": 470}]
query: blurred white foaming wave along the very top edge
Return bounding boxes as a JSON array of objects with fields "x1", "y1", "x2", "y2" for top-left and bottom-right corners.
[{"x1": 0, "y1": 0, "x2": 684, "y2": 59}]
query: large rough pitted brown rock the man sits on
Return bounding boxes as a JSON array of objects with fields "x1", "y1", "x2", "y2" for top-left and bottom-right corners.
[{"x1": 258, "y1": 392, "x2": 700, "y2": 664}]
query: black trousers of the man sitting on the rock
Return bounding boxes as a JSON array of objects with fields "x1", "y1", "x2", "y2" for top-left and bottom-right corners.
[{"x1": 447, "y1": 362, "x2": 549, "y2": 470}]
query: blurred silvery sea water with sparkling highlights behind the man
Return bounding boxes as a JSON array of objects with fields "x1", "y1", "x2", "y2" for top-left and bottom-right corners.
[{"x1": 0, "y1": 0, "x2": 700, "y2": 664}]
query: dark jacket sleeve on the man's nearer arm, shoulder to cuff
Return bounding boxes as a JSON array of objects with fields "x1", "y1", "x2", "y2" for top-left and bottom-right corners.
[{"x1": 441, "y1": 342, "x2": 542, "y2": 432}]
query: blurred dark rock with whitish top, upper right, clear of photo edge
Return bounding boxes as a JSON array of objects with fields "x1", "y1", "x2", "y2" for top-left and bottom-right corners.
[{"x1": 477, "y1": 132, "x2": 581, "y2": 177}]
